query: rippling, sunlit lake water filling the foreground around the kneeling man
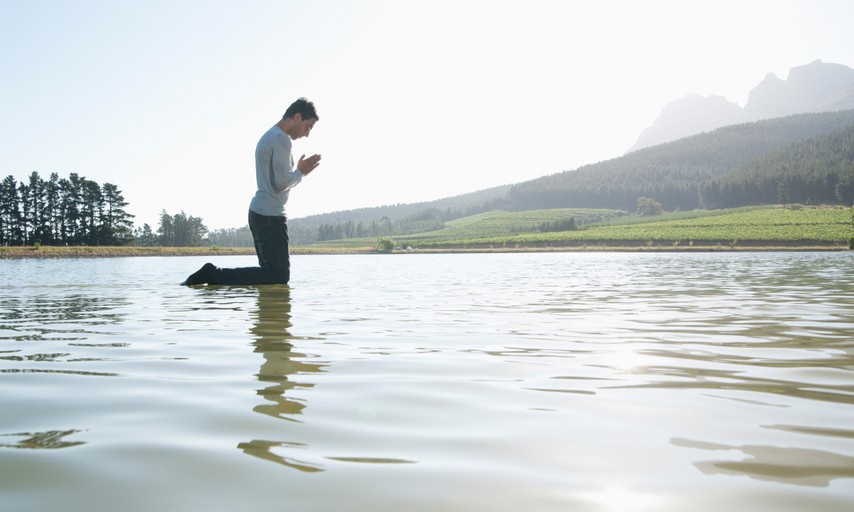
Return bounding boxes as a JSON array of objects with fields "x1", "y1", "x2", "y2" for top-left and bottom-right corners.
[{"x1": 0, "y1": 252, "x2": 854, "y2": 512}]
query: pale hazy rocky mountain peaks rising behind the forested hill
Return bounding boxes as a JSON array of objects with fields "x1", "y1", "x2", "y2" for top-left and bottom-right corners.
[{"x1": 629, "y1": 60, "x2": 854, "y2": 152}]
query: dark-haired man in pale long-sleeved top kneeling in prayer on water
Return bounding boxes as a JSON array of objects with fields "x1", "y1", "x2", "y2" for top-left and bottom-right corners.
[{"x1": 181, "y1": 98, "x2": 320, "y2": 286}]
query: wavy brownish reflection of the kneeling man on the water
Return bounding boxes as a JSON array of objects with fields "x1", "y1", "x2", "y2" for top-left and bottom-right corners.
[{"x1": 238, "y1": 285, "x2": 324, "y2": 471}]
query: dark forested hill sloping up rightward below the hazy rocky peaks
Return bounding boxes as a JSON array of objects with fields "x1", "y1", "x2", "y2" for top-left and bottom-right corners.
[{"x1": 505, "y1": 110, "x2": 854, "y2": 211}]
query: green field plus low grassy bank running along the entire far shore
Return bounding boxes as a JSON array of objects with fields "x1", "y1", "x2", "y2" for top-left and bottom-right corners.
[{"x1": 0, "y1": 207, "x2": 854, "y2": 259}]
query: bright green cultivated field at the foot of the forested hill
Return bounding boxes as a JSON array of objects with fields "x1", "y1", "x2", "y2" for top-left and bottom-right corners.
[{"x1": 324, "y1": 207, "x2": 854, "y2": 250}]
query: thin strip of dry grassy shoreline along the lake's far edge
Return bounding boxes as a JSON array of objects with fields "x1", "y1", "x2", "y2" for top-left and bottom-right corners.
[{"x1": 0, "y1": 244, "x2": 849, "y2": 259}]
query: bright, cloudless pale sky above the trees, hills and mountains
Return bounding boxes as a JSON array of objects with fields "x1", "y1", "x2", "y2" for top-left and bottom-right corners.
[{"x1": 0, "y1": 0, "x2": 854, "y2": 230}]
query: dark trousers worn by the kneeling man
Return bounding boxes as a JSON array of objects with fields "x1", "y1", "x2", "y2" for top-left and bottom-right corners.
[{"x1": 212, "y1": 210, "x2": 291, "y2": 284}]
